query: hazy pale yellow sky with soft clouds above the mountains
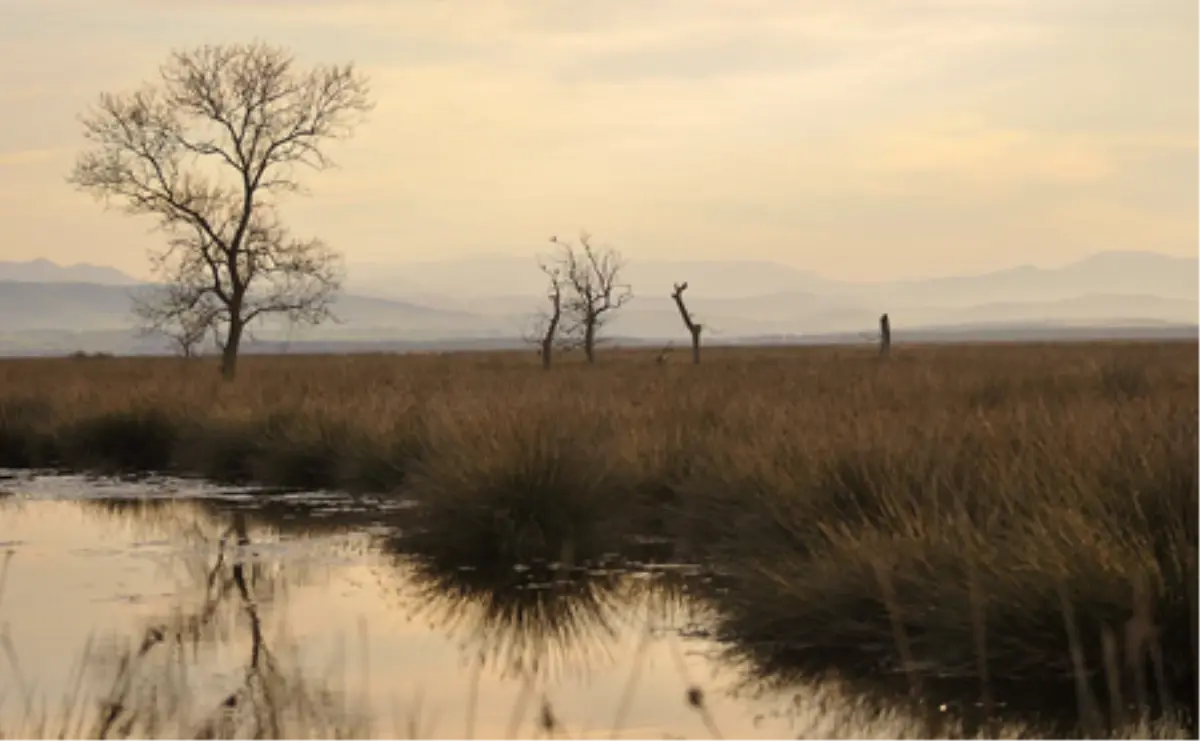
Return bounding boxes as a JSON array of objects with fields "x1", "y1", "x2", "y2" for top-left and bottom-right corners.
[{"x1": 0, "y1": 0, "x2": 1200, "y2": 279}]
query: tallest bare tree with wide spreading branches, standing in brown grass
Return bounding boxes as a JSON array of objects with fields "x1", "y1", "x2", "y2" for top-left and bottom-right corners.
[{"x1": 68, "y1": 42, "x2": 371, "y2": 378}]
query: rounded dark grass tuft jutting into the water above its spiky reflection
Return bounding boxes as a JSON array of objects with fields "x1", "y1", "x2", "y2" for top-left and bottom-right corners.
[{"x1": 403, "y1": 405, "x2": 640, "y2": 564}]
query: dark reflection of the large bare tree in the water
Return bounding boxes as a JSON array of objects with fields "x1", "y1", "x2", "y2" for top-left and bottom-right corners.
[{"x1": 51, "y1": 500, "x2": 367, "y2": 740}]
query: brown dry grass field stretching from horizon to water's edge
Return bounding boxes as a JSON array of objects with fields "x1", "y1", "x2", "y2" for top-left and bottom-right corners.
[{"x1": 0, "y1": 344, "x2": 1200, "y2": 717}]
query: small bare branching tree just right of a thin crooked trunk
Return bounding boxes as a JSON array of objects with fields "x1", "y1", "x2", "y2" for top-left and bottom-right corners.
[{"x1": 550, "y1": 227, "x2": 634, "y2": 363}]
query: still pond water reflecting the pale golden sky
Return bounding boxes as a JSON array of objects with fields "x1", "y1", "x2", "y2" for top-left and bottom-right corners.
[{"x1": 0, "y1": 472, "x2": 864, "y2": 741}]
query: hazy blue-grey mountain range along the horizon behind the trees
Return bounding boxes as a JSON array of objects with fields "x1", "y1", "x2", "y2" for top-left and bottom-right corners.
[{"x1": 0, "y1": 252, "x2": 1200, "y2": 355}]
